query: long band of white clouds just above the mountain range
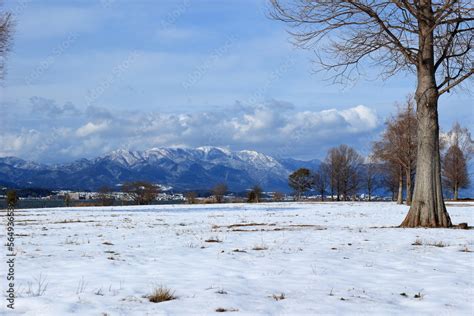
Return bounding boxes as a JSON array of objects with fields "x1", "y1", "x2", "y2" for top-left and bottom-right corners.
[{"x1": 0, "y1": 97, "x2": 380, "y2": 162}]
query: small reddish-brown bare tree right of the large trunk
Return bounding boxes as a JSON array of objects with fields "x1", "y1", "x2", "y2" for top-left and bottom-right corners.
[{"x1": 442, "y1": 145, "x2": 470, "y2": 201}]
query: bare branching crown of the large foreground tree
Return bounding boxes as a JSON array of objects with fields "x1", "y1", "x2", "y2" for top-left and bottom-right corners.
[{"x1": 270, "y1": 0, "x2": 474, "y2": 89}]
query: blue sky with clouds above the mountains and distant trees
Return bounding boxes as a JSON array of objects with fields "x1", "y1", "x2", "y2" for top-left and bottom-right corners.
[{"x1": 0, "y1": 0, "x2": 474, "y2": 162}]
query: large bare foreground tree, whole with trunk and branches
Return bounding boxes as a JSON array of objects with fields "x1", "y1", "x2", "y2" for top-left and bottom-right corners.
[{"x1": 270, "y1": 0, "x2": 474, "y2": 227}]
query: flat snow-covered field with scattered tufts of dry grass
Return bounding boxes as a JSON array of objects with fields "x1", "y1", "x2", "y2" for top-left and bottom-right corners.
[{"x1": 0, "y1": 202, "x2": 474, "y2": 315}]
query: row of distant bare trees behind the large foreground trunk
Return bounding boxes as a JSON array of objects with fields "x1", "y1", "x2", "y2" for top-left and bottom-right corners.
[{"x1": 288, "y1": 96, "x2": 474, "y2": 205}]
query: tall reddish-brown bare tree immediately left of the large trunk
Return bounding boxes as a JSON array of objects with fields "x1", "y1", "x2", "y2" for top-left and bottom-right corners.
[{"x1": 373, "y1": 96, "x2": 417, "y2": 205}]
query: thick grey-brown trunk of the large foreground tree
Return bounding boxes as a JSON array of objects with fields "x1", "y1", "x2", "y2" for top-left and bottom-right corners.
[{"x1": 400, "y1": 0, "x2": 452, "y2": 227}]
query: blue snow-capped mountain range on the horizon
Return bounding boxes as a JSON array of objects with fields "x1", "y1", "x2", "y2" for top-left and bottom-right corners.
[{"x1": 0, "y1": 146, "x2": 319, "y2": 191}]
